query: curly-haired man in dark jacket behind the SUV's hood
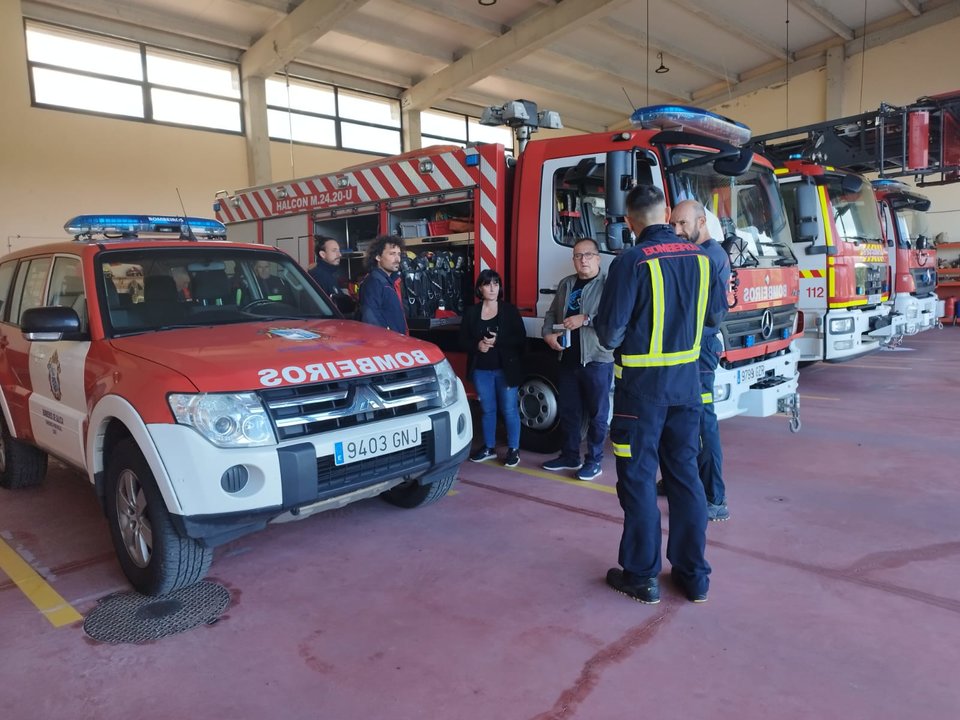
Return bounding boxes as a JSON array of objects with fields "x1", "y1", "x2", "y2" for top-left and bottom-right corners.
[{"x1": 360, "y1": 235, "x2": 407, "y2": 334}]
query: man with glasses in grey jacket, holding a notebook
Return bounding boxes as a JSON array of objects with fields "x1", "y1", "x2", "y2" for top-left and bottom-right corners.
[{"x1": 542, "y1": 238, "x2": 613, "y2": 480}]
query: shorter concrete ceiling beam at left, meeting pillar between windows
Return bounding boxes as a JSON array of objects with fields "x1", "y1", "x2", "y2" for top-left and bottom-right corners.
[{"x1": 240, "y1": 0, "x2": 368, "y2": 77}]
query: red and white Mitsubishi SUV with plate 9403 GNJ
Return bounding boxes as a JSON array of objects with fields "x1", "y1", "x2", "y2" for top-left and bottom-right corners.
[{"x1": 0, "y1": 215, "x2": 472, "y2": 595}]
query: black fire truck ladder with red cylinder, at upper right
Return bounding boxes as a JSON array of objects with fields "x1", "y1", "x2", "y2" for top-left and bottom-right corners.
[{"x1": 753, "y1": 91, "x2": 960, "y2": 186}]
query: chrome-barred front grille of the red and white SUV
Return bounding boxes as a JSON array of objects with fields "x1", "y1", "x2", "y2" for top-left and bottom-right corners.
[{"x1": 260, "y1": 367, "x2": 440, "y2": 440}]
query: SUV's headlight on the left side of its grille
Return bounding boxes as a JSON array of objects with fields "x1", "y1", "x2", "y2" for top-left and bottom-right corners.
[{"x1": 167, "y1": 393, "x2": 276, "y2": 447}]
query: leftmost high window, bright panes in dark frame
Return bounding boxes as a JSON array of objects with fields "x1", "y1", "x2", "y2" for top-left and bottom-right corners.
[{"x1": 26, "y1": 21, "x2": 242, "y2": 133}]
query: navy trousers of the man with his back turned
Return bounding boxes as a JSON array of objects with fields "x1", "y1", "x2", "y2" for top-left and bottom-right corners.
[{"x1": 610, "y1": 388, "x2": 710, "y2": 590}]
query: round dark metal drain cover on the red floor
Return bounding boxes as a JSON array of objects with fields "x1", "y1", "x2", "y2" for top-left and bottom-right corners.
[{"x1": 83, "y1": 581, "x2": 230, "y2": 645}]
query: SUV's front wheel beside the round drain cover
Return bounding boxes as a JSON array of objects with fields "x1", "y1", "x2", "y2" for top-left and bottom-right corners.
[{"x1": 106, "y1": 440, "x2": 213, "y2": 595}]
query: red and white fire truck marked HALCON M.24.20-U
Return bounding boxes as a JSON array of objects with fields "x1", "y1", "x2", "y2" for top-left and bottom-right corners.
[{"x1": 214, "y1": 100, "x2": 800, "y2": 438}]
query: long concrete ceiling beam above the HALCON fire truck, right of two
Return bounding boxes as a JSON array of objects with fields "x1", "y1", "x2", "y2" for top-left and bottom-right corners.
[{"x1": 400, "y1": 0, "x2": 627, "y2": 110}]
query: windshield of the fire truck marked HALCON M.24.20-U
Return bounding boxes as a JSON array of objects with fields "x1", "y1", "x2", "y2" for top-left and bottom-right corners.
[{"x1": 670, "y1": 150, "x2": 797, "y2": 267}]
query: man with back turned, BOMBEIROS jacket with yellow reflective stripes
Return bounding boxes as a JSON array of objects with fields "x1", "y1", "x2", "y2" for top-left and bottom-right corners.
[{"x1": 595, "y1": 185, "x2": 726, "y2": 604}]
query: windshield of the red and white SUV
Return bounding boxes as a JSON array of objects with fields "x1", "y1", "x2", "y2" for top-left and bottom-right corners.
[{"x1": 97, "y1": 246, "x2": 336, "y2": 336}]
